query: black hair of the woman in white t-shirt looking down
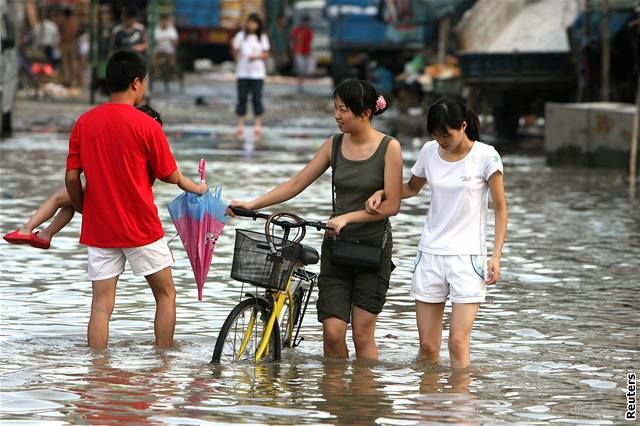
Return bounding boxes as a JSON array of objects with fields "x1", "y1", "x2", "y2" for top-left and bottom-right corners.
[{"x1": 427, "y1": 96, "x2": 480, "y2": 141}]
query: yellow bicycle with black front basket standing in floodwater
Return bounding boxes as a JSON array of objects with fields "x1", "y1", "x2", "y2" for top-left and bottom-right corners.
[{"x1": 211, "y1": 208, "x2": 329, "y2": 363}]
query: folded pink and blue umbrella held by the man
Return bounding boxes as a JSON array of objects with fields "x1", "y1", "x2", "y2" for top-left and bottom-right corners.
[{"x1": 168, "y1": 160, "x2": 228, "y2": 300}]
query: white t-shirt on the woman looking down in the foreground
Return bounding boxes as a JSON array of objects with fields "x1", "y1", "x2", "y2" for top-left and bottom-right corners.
[{"x1": 411, "y1": 141, "x2": 502, "y2": 255}]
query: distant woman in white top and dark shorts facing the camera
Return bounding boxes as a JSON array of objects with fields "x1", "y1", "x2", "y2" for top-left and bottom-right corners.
[{"x1": 232, "y1": 13, "x2": 270, "y2": 140}]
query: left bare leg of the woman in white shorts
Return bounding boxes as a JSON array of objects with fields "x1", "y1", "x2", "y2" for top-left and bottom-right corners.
[{"x1": 416, "y1": 300, "x2": 444, "y2": 363}]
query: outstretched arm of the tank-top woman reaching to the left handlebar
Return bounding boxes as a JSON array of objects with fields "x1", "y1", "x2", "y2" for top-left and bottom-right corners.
[{"x1": 231, "y1": 139, "x2": 331, "y2": 210}]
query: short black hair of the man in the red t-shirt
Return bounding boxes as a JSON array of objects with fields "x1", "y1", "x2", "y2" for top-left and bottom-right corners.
[{"x1": 106, "y1": 49, "x2": 147, "y2": 93}]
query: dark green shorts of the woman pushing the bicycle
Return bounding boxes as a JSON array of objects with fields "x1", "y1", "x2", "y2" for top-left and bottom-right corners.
[{"x1": 317, "y1": 236, "x2": 395, "y2": 323}]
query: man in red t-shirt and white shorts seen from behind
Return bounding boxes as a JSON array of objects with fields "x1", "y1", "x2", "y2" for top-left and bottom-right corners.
[{"x1": 65, "y1": 50, "x2": 207, "y2": 348}]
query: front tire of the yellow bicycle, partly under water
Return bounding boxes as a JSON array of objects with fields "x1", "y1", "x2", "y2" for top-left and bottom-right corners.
[{"x1": 211, "y1": 298, "x2": 280, "y2": 363}]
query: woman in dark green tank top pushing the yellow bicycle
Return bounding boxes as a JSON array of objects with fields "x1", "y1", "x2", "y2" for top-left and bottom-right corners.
[{"x1": 231, "y1": 80, "x2": 402, "y2": 359}]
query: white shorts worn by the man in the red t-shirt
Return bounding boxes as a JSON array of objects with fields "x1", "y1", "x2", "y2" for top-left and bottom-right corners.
[{"x1": 87, "y1": 237, "x2": 173, "y2": 281}]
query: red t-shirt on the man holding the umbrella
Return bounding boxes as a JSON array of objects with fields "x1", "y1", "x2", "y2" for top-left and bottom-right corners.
[{"x1": 67, "y1": 103, "x2": 177, "y2": 248}]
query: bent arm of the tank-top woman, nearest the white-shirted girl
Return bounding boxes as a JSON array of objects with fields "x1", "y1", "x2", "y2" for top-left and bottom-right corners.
[{"x1": 327, "y1": 139, "x2": 402, "y2": 234}]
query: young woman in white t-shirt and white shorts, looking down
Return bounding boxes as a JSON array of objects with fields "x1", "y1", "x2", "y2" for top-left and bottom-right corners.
[{"x1": 366, "y1": 98, "x2": 507, "y2": 368}]
